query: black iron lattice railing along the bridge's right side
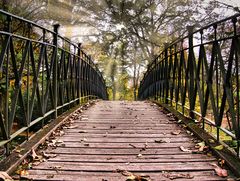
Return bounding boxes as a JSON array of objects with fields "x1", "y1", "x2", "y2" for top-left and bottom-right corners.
[{"x1": 138, "y1": 14, "x2": 240, "y2": 156}]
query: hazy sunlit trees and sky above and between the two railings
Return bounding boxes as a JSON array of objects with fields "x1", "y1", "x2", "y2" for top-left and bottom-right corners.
[{"x1": 2, "y1": 0, "x2": 236, "y2": 98}]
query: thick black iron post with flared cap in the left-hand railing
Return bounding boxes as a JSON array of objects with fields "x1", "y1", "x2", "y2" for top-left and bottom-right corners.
[{"x1": 53, "y1": 24, "x2": 60, "y2": 118}]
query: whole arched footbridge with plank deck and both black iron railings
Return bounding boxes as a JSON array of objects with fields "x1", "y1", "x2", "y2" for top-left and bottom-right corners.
[{"x1": 0, "y1": 10, "x2": 240, "y2": 181}]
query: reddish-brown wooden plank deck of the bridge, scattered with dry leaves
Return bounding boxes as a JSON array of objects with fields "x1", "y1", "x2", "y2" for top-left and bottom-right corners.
[{"x1": 24, "y1": 101, "x2": 232, "y2": 181}]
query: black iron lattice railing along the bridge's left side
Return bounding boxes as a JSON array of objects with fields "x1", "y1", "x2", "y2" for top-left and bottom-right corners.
[{"x1": 0, "y1": 10, "x2": 107, "y2": 154}]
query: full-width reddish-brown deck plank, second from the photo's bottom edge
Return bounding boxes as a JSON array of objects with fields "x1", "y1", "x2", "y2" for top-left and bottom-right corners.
[{"x1": 33, "y1": 162, "x2": 214, "y2": 172}]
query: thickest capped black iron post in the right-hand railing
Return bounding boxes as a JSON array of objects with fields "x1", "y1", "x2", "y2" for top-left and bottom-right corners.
[{"x1": 187, "y1": 26, "x2": 195, "y2": 119}]
